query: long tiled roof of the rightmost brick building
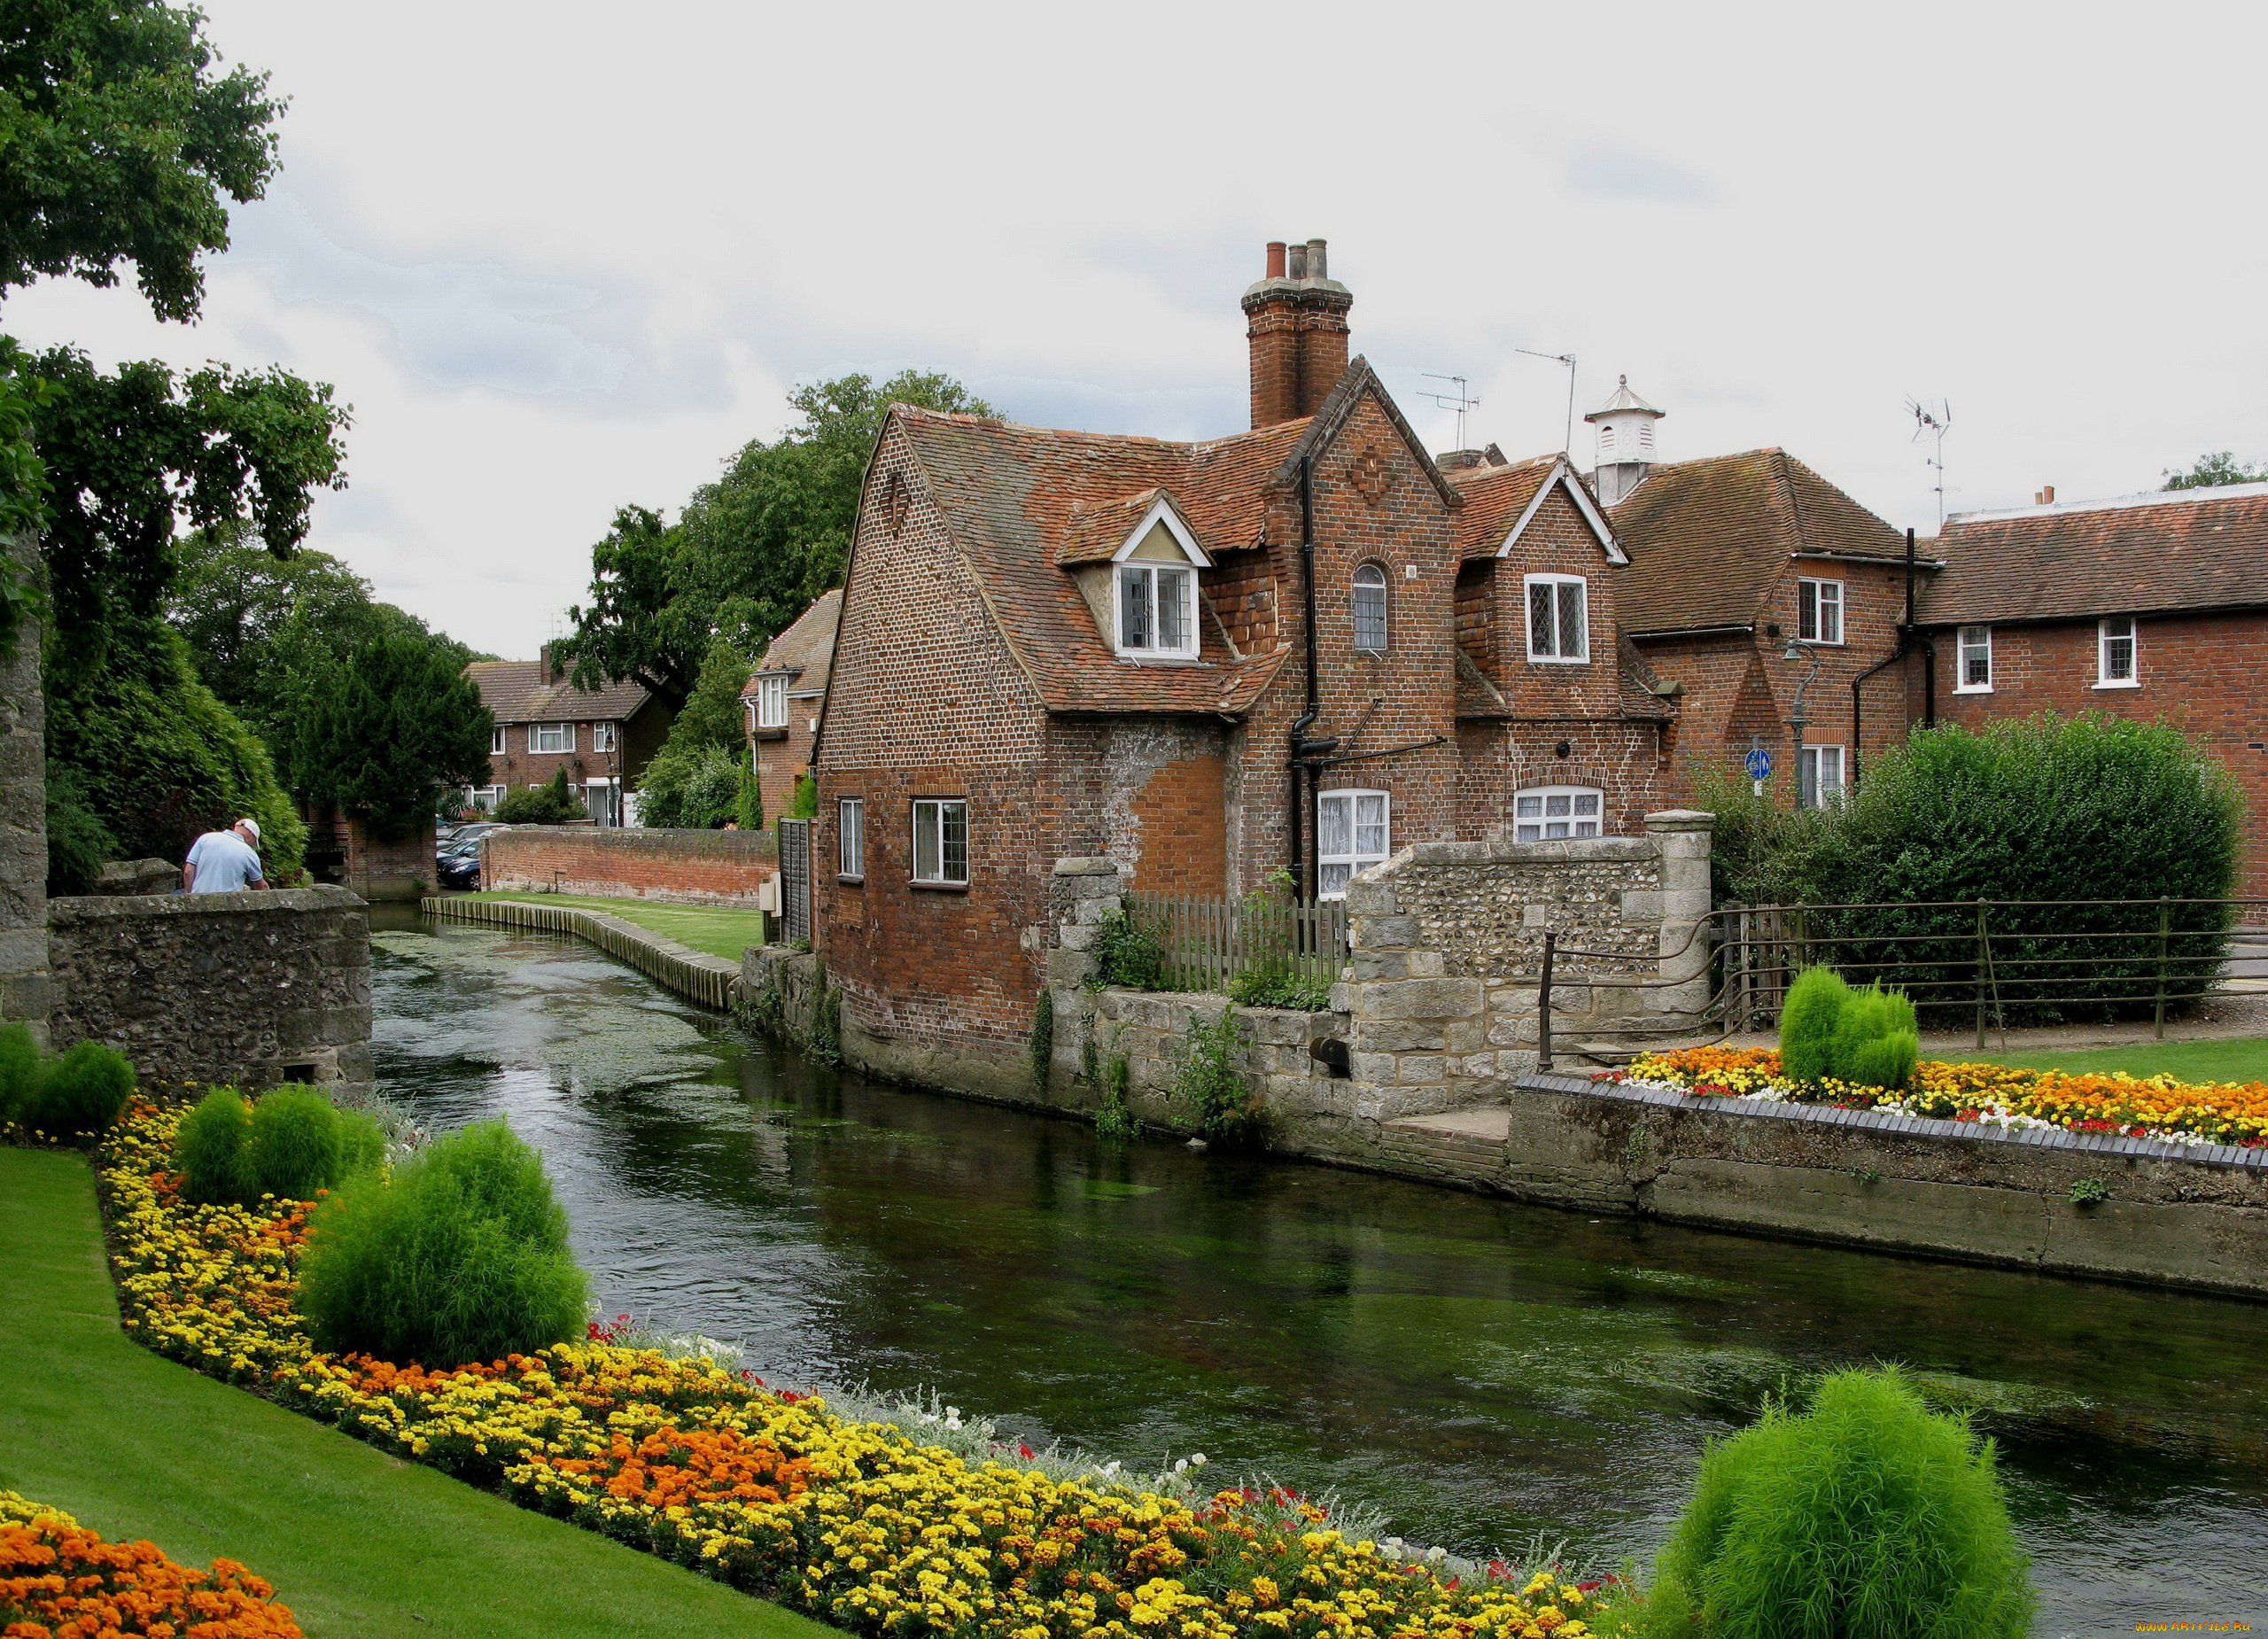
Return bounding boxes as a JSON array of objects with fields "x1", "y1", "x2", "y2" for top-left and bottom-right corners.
[{"x1": 1921, "y1": 483, "x2": 2268, "y2": 625}]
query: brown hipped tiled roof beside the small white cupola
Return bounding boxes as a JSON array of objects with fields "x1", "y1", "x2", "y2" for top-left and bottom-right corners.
[{"x1": 1608, "y1": 449, "x2": 1905, "y2": 633}]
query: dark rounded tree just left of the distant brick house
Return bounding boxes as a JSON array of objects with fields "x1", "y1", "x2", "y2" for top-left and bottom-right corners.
[{"x1": 284, "y1": 633, "x2": 494, "y2": 841}]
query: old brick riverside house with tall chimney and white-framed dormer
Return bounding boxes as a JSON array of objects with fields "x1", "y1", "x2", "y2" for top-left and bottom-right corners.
[{"x1": 807, "y1": 240, "x2": 1676, "y2": 1088}]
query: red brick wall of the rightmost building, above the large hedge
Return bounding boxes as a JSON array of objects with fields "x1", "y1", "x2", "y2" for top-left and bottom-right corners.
[{"x1": 1932, "y1": 614, "x2": 2268, "y2": 897}]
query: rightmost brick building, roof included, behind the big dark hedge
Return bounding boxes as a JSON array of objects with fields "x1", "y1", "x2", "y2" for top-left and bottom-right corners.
[{"x1": 1921, "y1": 483, "x2": 2268, "y2": 902}]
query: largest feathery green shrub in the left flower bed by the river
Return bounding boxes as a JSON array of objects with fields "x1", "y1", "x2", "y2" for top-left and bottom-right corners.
[{"x1": 299, "y1": 1122, "x2": 590, "y2": 1367}]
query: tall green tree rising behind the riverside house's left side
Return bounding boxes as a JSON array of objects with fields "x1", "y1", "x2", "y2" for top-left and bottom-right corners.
[{"x1": 558, "y1": 369, "x2": 991, "y2": 705}]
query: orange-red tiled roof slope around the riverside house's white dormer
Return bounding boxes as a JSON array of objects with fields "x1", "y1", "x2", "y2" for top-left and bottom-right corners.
[{"x1": 891, "y1": 406, "x2": 1309, "y2": 711}]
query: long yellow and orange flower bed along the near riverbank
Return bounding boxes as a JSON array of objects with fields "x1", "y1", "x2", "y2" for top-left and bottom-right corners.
[{"x1": 97, "y1": 1102, "x2": 1596, "y2": 1639}]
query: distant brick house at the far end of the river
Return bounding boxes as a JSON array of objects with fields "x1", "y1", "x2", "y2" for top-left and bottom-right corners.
[{"x1": 465, "y1": 649, "x2": 673, "y2": 825}]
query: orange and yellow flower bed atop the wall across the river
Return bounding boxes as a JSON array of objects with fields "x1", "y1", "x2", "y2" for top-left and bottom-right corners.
[{"x1": 1601, "y1": 1047, "x2": 2268, "y2": 1149}]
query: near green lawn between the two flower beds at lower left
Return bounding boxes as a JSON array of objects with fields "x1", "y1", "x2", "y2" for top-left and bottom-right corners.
[{"x1": 0, "y1": 1149, "x2": 835, "y2": 1639}]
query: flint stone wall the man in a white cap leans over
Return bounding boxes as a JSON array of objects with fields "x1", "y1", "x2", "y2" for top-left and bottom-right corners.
[{"x1": 48, "y1": 886, "x2": 372, "y2": 1091}]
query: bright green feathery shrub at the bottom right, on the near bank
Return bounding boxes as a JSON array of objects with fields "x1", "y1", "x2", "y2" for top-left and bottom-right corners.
[{"x1": 1647, "y1": 1370, "x2": 2032, "y2": 1639}]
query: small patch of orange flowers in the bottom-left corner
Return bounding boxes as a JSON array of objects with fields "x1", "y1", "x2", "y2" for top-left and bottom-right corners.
[{"x1": 0, "y1": 1492, "x2": 301, "y2": 1639}]
